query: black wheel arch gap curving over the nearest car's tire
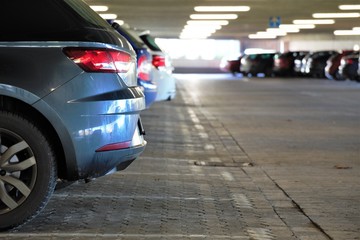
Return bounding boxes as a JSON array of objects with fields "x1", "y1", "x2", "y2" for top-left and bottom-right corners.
[{"x1": 0, "y1": 95, "x2": 69, "y2": 179}]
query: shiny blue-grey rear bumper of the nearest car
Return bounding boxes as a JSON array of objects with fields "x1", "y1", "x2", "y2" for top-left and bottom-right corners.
[{"x1": 36, "y1": 74, "x2": 146, "y2": 181}]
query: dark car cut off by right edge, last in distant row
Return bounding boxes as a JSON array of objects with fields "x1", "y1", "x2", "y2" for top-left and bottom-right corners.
[{"x1": 339, "y1": 52, "x2": 360, "y2": 81}]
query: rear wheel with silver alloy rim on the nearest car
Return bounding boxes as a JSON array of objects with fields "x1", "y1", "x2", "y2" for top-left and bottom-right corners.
[{"x1": 0, "y1": 111, "x2": 56, "y2": 230}]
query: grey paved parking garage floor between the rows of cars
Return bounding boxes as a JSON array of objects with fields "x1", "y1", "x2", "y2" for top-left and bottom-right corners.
[{"x1": 0, "y1": 75, "x2": 360, "y2": 240}]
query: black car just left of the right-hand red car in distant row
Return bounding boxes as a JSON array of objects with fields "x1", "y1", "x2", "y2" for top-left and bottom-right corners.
[{"x1": 304, "y1": 51, "x2": 336, "y2": 78}]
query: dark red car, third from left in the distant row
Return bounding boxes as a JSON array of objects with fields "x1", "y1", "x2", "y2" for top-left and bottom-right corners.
[{"x1": 273, "y1": 51, "x2": 307, "y2": 76}]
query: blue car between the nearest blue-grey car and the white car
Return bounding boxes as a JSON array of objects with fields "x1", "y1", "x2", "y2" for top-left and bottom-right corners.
[{"x1": 109, "y1": 20, "x2": 161, "y2": 108}]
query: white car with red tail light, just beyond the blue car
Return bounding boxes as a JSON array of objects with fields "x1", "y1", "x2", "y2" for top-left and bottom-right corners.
[{"x1": 136, "y1": 29, "x2": 176, "y2": 101}]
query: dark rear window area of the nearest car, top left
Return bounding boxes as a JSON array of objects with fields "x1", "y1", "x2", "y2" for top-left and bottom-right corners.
[{"x1": 0, "y1": 0, "x2": 111, "y2": 41}]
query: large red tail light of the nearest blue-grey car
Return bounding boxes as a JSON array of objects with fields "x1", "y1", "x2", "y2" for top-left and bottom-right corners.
[{"x1": 64, "y1": 48, "x2": 132, "y2": 73}]
